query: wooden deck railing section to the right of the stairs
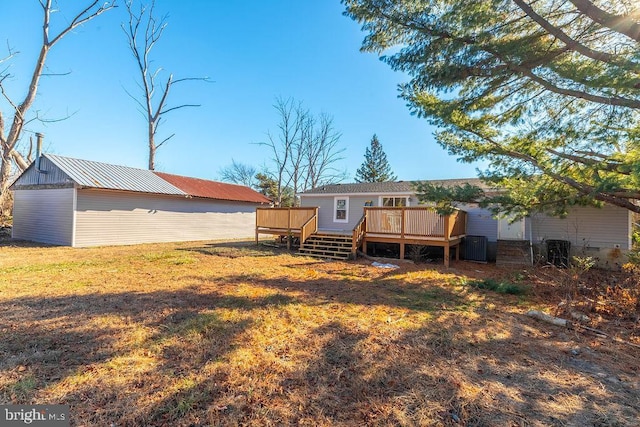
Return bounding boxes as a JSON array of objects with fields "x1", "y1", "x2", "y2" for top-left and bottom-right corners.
[{"x1": 365, "y1": 207, "x2": 466, "y2": 239}]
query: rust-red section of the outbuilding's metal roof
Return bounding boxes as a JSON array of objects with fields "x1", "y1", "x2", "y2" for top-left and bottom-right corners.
[{"x1": 154, "y1": 172, "x2": 271, "y2": 203}]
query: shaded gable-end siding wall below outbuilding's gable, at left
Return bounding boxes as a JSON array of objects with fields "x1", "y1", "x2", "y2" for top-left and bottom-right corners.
[{"x1": 12, "y1": 188, "x2": 76, "y2": 246}]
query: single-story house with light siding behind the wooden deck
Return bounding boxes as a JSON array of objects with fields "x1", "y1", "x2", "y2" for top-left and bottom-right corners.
[{"x1": 298, "y1": 178, "x2": 633, "y2": 268}]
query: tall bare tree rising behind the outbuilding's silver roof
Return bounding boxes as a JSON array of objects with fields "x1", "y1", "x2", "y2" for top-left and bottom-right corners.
[{"x1": 122, "y1": 0, "x2": 208, "y2": 170}]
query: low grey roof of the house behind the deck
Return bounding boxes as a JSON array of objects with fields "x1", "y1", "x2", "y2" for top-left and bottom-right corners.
[{"x1": 300, "y1": 178, "x2": 486, "y2": 196}]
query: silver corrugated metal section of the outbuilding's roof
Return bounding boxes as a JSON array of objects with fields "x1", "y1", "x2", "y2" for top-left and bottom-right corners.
[{"x1": 43, "y1": 154, "x2": 187, "y2": 196}]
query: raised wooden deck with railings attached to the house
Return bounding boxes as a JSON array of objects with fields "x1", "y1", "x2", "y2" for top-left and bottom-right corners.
[{"x1": 256, "y1": 207, "x2": 467, "y2": 267}]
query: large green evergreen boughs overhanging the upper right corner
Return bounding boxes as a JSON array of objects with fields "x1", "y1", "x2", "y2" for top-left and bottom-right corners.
[{"x1": 342, "y1": 0, "x2": 640, "y2": 215}]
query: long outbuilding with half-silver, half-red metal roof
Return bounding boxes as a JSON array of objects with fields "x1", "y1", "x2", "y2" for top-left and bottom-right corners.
[{"x1": 11, "y1": 154, "x2": 271, "y2": 247}]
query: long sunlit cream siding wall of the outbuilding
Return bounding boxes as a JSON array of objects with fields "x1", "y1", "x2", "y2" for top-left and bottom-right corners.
[{"x1": 75, "y1": 189, "x2": 257, "y2": 247}]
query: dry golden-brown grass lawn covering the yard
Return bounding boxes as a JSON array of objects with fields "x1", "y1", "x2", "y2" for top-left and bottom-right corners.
[{"x1": 0, "y1": 242, "x2": 640, "y2": 426}]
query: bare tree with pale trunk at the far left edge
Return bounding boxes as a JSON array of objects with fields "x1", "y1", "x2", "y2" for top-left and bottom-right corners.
[{"x1": 0, "y1": 0, "x2": 115, "y2": 214}]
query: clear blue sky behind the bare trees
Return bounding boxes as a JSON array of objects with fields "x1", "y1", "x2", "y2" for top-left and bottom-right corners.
[{"x1": 0, "y1": 0, "x2": 476, "y2": 181}]
